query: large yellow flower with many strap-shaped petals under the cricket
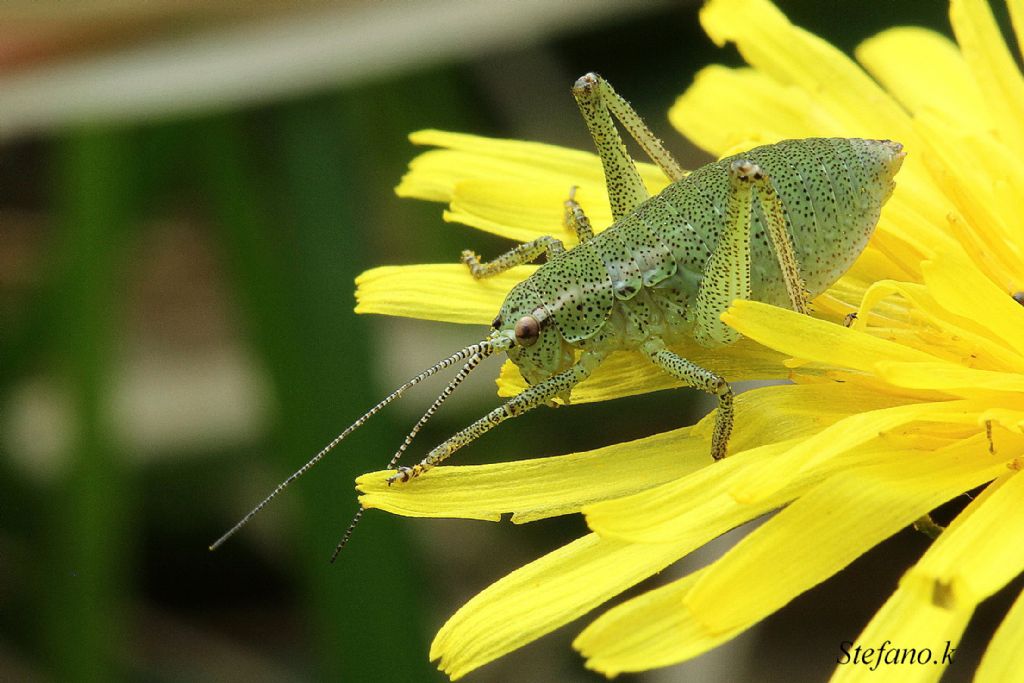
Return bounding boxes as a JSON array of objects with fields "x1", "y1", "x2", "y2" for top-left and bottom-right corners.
[{"x1": 357, "y1": 0, "x2": 1024, "y2": 681}]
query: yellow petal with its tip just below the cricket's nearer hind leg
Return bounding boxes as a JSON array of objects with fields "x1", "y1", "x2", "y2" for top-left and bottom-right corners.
[{"x1": 722, "y1": 299, "x2": 935, "y2": 372}]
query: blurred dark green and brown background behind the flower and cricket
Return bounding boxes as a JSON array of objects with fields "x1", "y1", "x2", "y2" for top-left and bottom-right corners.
[{"x1": 0, "y1": 0, "x2": 1001, "y2": 681}]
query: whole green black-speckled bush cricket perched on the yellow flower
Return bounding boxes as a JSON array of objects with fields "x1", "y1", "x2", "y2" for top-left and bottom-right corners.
[{"x1": 210, "y1": 74, "x2": 905, "y2": 560}]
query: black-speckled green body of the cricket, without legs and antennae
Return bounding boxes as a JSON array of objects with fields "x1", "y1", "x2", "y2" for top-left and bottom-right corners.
[{"x1": 502, "y1": 138, "x2": 902, "y2": 382}]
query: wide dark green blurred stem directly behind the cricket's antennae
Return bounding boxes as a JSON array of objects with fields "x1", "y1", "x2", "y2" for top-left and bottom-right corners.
[{"x1": 200, "y1": 100, "x2": 436, "y2": 681}]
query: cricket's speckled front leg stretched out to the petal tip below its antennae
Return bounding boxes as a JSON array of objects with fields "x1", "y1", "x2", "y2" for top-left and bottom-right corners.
[{"x1": 387, "y1": 352, "x2": 605, "y2": 486}]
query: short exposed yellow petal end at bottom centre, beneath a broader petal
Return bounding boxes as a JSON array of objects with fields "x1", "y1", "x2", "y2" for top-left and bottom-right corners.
[{"x1": 572, "y1": 569, "x2": 739, "y2": 678}]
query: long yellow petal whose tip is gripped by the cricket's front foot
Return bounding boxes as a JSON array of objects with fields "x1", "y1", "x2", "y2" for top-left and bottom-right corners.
[{"x1": 356, "y1": 384, "x2": 891, "y2": 528}]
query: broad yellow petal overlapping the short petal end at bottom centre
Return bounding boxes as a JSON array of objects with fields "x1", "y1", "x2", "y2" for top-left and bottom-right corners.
[{"x1": 685, "y1": 436, "x2": 1006, "y2": 633}]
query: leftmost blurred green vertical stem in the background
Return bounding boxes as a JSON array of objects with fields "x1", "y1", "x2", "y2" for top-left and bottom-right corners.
[{"x1": 44, "y1": 131, "x2": 134, "y2": 681}]
